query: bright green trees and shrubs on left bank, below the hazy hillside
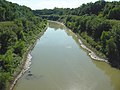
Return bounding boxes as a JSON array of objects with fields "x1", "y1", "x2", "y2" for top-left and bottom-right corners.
[{"x1": 0, "y1": 16, "x2": 46, "y2": 90}]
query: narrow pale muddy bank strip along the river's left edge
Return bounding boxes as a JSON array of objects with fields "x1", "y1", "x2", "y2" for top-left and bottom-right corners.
[{"x1": 9, "y1": 23, "x2": 49, "y2": 90}]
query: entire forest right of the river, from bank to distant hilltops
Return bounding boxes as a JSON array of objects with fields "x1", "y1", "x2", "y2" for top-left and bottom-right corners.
[{"x1": 33, "y1": 0, "x2": 120, "y2": 69}]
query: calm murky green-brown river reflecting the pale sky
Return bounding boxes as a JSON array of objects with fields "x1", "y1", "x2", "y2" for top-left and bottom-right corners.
[{"x1": 14, "y1": 22, "x2": 120, "y2": 90}]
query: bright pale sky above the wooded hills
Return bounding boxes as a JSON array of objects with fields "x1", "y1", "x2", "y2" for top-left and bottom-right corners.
[{"x1": 7, "y1": 0, "x2": 120, "y2": 10}]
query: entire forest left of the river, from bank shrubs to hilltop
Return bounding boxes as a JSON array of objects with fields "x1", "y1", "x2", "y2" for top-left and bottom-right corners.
[{"x1": 0, "y1": 0, "x2": 47, "y2": 90}]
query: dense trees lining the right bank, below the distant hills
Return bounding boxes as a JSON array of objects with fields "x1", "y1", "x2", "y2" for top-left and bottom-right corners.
[{"x1": 66, "y1": 16, "x2": 120, "y2": 68}]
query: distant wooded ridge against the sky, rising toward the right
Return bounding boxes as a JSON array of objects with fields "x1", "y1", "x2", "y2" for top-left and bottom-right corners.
[{"x1": 33, "y1": 0, "x2": 120, "y2": 20}]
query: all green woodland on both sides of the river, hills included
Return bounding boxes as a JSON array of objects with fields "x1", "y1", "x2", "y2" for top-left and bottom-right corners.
[{"x1": 0, "y1": 0, "x2": 120, "y2": 90}]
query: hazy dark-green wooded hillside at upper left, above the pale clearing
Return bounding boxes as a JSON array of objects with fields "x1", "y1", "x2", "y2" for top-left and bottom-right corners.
[{"x1": 0, "y1": 0, "x2": 33, "y2": 21}]
